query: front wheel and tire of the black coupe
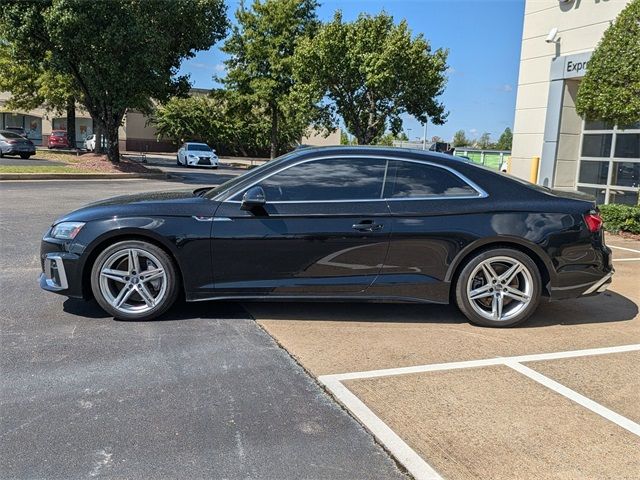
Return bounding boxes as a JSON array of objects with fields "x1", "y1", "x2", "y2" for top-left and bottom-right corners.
[{"x1": 91, "y1": 240, "x2": 180, "y2": 321}]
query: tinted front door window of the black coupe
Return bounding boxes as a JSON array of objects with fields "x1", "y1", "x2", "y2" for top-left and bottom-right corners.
[{"x1": 259, "y1": 158, "x2": 386, "y2": 202}]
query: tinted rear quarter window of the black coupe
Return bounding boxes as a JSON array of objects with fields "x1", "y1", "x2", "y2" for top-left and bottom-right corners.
[{"x1": 384, "y1": 160, "x2": 478, "y2": 198}]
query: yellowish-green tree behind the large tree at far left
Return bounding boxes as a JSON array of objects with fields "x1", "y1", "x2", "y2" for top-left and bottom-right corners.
[{"x1": 0, "y1": 43, "x2": 77, "y2": 145}]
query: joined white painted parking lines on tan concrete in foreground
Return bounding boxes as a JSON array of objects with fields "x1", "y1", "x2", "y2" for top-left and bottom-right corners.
[{"x1": 318, "y1": 344, "x2": 640, "y2": 480}]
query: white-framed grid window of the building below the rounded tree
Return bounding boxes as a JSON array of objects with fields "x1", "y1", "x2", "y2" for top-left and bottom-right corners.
[{"x1": 576, "y1": 121, "x2": 640, "y2": 205}]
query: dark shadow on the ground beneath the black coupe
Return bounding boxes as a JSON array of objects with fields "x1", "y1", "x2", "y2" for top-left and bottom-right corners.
[{"x1": 63, "y1": 292, "x2": 638, "y2": 328}]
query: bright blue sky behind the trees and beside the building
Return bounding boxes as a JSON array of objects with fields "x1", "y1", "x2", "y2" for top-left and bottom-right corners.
[{"x1": 180, "y1": 0, "x2": 524, "y2": 140}]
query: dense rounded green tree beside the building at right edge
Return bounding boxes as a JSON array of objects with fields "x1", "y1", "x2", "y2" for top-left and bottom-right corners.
[{"x1": 576, "y1": 0, "x2": 640, "y2": 126}]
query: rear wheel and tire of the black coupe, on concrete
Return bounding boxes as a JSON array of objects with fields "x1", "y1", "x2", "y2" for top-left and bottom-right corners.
[{"x1": 455, "y1": 248, "x2": 542, "y2": 327}]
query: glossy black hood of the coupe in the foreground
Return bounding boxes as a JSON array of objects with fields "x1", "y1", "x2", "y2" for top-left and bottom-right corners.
[{"x1": 54, "y1": 190, "x2": 217, "y2": 223}]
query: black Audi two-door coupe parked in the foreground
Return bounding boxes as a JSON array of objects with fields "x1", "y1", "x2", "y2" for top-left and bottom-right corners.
[{"x1": 40, "y1": 147, "x2": 613, "y2": 327}]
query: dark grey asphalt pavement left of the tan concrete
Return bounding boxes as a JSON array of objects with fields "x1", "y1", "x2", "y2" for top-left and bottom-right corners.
[{"x1": 0, "y1": 176, "x2": 405, "y2": 479}]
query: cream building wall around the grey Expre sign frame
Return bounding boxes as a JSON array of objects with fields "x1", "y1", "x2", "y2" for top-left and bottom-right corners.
[{"x1": 511, "y1": 0, "x2": 628, "y2": 182}]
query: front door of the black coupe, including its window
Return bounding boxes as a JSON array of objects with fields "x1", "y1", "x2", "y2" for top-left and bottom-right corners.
[{"x1": 212, "y1": 157, "x2": 391, "y2": 296}]
